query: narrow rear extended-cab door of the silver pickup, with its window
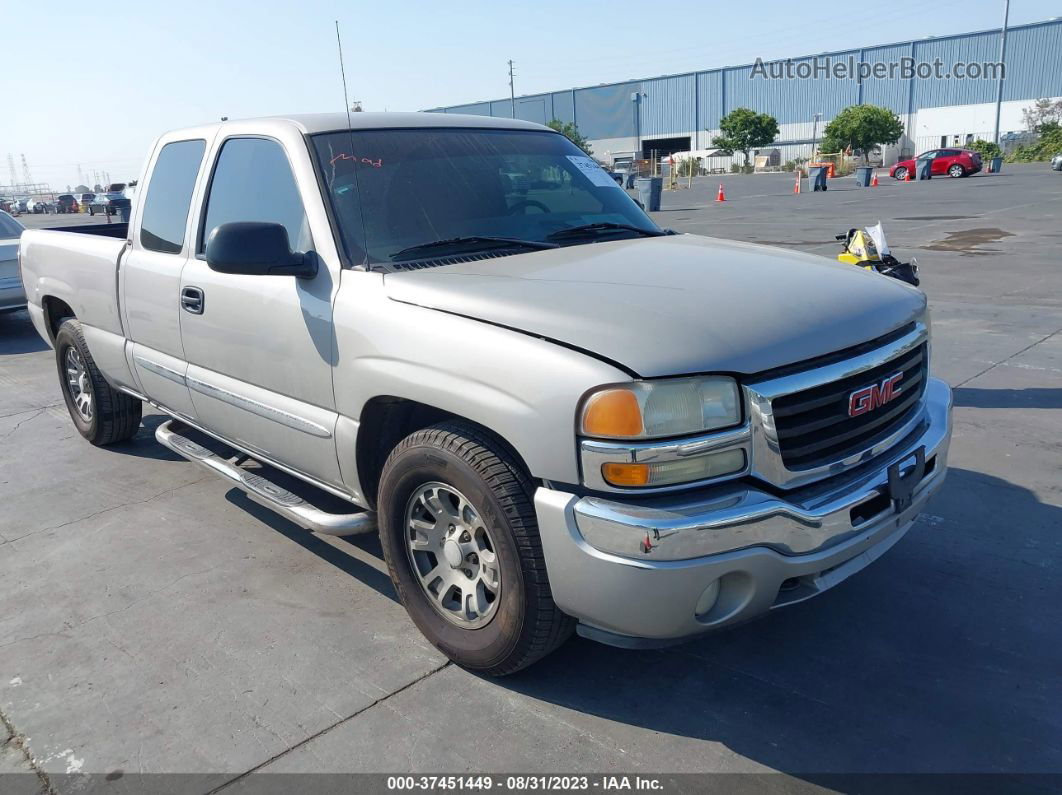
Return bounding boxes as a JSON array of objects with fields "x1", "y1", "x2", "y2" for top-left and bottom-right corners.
[{"x1": 119, "y1": 136, "x2": 207, "y2": 418}]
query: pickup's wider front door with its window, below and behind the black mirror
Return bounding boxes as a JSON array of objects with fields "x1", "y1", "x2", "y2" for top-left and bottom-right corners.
[{"x1": 174, "y1": 133, "x2": 342, "y2": 487}]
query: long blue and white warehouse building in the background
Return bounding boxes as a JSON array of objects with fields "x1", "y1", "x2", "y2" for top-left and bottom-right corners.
[{"x1": 432, "y1": 19, "x2": 1062, "y2": 165}]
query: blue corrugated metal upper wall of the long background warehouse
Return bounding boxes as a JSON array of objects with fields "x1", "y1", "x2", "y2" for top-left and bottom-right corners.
[{"x1": 435, "y1": 20, "x2": 1062, "y2": 139}]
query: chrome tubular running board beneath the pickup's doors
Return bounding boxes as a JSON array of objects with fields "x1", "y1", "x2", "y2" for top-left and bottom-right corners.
[{"x1": 155, "y1": 419, "x2": 376, "y2": 536}]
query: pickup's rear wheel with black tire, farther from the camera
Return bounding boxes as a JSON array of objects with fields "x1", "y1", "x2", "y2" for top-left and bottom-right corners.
[{"x1": 55, "y1": 317, "x2": 143, "y2": 447}]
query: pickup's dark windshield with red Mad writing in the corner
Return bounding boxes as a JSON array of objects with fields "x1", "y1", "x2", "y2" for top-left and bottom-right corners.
[{"x1": 313, "y1": 127, "x2": 661, "y2": 267}]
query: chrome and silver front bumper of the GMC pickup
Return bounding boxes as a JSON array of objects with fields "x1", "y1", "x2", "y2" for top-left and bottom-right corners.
[{"x1": 535, "y1": 379, "x2": 952, "y2": 645}]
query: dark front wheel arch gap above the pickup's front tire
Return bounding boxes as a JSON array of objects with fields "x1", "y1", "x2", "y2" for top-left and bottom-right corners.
[{"x1": 355, "y1": 395, "x2": 533, "y2": 509}]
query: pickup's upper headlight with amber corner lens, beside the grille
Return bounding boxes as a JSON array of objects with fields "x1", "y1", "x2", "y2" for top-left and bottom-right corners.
[{"x1": 580, "y1": 376, "x2": 741, "y2": 439}]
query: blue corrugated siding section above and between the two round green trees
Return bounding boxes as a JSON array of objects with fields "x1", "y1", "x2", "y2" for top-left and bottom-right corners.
[{"x1": 723, "y1": 50, "x2": 859, "y2": 124}]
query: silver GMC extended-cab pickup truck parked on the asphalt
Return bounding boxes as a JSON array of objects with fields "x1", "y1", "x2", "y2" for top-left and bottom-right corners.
[{"x1": 19, "y1": 114, "x2": 952, "y2": 674}]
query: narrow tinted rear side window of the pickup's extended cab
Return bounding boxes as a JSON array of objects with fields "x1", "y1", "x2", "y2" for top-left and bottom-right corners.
[{"x1": 140, "y1": 140, "x2": 206, "y2": 254}]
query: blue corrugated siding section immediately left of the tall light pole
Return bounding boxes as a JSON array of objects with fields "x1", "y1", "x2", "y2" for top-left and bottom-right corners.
[{"x1": 912, "y1": 33, "x2": 999, "y2": 110}]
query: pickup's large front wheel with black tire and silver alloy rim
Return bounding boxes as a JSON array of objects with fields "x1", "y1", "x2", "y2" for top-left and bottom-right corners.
[{"x1": 377, "y1": 421, "x2": 575, "y2": 676}]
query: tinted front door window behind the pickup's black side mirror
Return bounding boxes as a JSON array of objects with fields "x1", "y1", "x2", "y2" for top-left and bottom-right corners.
[{"x1": 200, "y1": 138, "x2": 311, "y2": 252}]
